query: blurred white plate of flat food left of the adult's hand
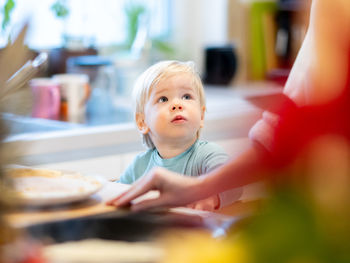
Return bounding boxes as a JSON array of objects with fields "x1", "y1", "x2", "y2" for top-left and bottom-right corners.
[{"x1": 5, "y1": 167, "x2": 103, "y2": 206}]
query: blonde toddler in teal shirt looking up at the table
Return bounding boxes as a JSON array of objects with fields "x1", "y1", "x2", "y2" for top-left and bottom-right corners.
[{"x1": 119, "y1": 61, "x2": 241, "y2": 210}]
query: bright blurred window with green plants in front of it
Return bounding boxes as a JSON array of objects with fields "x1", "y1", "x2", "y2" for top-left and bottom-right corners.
[{"x1": 0, "y1": 0, "x2": 170, "y2": 49}]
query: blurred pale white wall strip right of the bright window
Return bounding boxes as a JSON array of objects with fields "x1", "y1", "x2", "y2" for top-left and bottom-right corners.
[{"x1": 172, "y1": 0, "x2": 228, "y2": 72}]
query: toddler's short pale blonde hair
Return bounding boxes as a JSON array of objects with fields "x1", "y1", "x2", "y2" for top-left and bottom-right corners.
[{"x1": 133, "y1": 60, "x2": 205, "y2": 149}]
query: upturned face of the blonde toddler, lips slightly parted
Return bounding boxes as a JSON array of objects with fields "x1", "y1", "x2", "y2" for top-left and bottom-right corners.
[{"x1": 137, "y1": 73, "x2": 205, "y2": 147}]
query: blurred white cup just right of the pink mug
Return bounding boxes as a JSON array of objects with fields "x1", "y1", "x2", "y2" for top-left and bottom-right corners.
[{"x1": 52, "y1": 74, "x2": 90, "y2": 122}]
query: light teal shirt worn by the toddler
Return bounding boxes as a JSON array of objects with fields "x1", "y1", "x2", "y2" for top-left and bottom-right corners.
[{"x1": 119, "y1": 140, "x2": 228, "y2": 184}]
